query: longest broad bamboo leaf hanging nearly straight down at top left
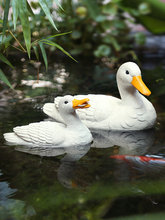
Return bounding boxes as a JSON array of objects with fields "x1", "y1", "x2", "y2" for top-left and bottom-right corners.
[{"x1": 19, "y1": 0, "x2": 31, "y2": 58}]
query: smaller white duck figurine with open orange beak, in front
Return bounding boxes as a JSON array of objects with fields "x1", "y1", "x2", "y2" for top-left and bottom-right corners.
[{"x1": 4, "y1": 95, "x2": 93, "y2": 147}]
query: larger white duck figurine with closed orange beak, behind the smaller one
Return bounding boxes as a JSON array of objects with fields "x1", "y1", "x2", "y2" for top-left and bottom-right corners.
[{"x1": 43, "y1": 62, "x2": 157, "y2": 131}]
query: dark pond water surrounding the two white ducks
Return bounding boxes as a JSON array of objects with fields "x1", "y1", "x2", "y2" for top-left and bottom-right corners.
[{"x1": 0, "y1": 53, "x2": 165, "y2": 220}]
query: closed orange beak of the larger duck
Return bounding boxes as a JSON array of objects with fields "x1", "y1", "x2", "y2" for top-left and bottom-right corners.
[{"x1": 131, "y1": 76, "x2": 151, "y2": 96}]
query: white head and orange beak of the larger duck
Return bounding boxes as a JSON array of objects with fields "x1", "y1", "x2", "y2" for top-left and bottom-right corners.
[{"x1": 117, "y1": 62, "x2": 151, "y2": 96}]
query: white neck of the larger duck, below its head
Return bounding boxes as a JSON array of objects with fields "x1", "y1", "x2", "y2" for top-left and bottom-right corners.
[{"x1": 119, "y1": 86, "x2": 143, "y2": 108}]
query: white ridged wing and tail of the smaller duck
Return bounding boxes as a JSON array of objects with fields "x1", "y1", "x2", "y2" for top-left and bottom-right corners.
[{"x1": 4, "y1": 122, "x2": 66, "y2": 146}]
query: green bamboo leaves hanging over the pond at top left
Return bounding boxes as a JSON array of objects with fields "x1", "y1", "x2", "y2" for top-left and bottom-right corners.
[{"x1": 0, "y1": 0, "x2": 74, "y2": 88}]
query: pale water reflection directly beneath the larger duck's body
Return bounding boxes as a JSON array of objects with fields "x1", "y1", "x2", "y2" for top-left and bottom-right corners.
[{"x1": 91, "y1": 129, "x2": 155, "y2": 155}]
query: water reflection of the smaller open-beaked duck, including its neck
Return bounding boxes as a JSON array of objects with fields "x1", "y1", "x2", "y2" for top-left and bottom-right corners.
[{"x1": 15, "y1": 144, "x2": 91, "y2": 189}]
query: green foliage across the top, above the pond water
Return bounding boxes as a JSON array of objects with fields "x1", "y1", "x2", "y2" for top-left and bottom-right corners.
[{"x1": 0, "y1": 0, "x2": 165, "y2": 86}]
